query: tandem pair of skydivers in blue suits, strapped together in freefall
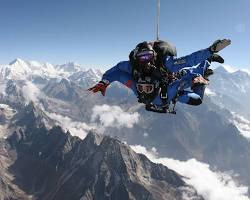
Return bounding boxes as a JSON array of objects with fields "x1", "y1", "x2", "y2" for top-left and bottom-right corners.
[{"x1": 88, "y1": 39, "x2": 231, "y2": 112}]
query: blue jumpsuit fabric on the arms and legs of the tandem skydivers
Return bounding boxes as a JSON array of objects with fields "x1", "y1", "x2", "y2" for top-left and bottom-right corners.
[{"x1": 102, "y1": 49, "x2": 212, "y2": 105}]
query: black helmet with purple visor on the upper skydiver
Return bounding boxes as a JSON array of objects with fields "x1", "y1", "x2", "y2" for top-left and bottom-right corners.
[{"x1": 133, "y1": 41, "x2": 156, "y2": 66}]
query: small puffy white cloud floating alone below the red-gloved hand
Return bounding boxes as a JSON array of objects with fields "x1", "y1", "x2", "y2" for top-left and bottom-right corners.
[{"x1": 91, "y1": 104, "x2": 139, "y2": 128}]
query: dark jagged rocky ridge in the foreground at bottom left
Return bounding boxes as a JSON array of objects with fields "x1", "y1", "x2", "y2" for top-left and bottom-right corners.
[{"x1": 0, "y1": 105, "x2": 203, "y2": 200}]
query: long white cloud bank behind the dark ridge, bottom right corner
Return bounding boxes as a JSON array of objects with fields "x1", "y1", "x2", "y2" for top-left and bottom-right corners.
[{"x1": 131, "y1": 145, "x2": 249, "y2": 200}]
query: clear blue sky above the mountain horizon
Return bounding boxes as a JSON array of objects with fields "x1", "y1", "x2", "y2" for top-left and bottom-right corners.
[{"x1": 0, "y1": 0, "x2": 250, "y2": 69}]
